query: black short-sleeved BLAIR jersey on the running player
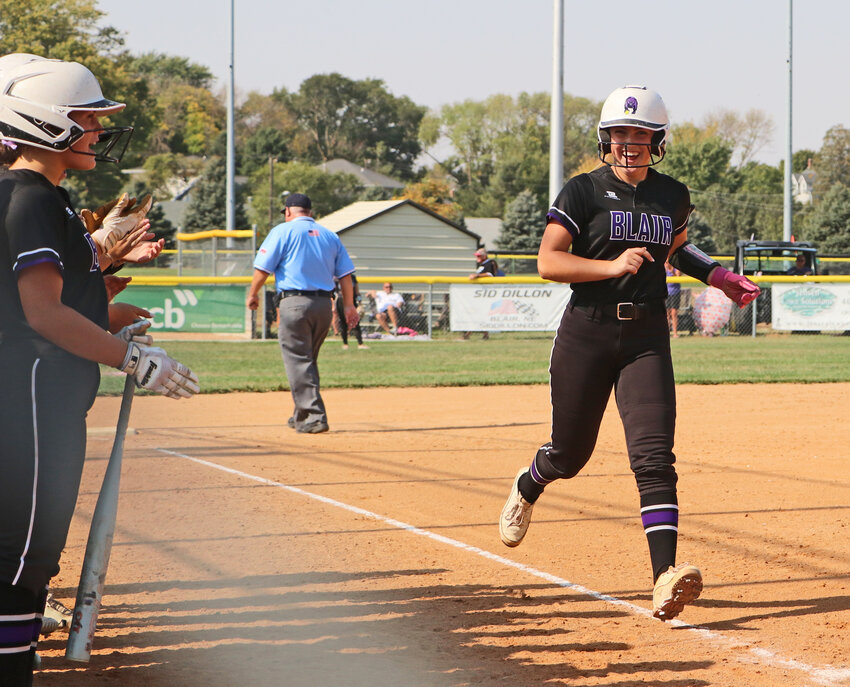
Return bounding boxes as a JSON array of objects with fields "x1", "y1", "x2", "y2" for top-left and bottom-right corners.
[{"x1": 547, "y1": 165, "x2": 693, "y2": 304}]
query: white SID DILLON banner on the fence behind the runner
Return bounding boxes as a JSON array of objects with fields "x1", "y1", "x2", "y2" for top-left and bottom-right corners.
[{"x1": 449, "y1": 284, "x2": 572, "y2": 332}]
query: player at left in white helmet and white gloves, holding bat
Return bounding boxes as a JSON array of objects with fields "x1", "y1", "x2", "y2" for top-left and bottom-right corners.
[{"x1": 0, "y1": 54, "x2": 199, "y2": 687}]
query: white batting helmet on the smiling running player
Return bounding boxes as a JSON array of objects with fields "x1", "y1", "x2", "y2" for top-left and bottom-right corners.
[{"x1": 597, "y1": 86, "x2": 670, "y2": 166}]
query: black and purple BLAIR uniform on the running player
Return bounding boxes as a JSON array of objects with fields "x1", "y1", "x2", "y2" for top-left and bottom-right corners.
[{"x1": 521, "y1": 166, "x2": 692, "y2": 577}]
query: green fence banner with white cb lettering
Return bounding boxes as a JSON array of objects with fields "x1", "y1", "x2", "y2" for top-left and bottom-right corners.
[{"x1": 115, "y1": 285, "x2": 246, "y2": 332}]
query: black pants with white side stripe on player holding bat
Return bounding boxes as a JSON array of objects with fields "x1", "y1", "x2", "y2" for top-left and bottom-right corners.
[{"x1": 0, "y1": 345, "x2": 100, "y2": 595}]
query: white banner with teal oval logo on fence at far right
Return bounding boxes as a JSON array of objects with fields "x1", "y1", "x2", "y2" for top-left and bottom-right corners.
[{"x1": 771, "y1": 282, "x2": 850, "y2": 331}]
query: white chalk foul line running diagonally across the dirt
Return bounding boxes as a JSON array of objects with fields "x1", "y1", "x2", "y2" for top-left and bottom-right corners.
[{"x1": 157, "y1": 448, "x2": 850, "y2": 685}]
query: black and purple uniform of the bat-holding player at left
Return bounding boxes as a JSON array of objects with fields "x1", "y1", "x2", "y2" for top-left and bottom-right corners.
[{"x1": 0, "y1": 170, "x2": 109, "y2": 684}]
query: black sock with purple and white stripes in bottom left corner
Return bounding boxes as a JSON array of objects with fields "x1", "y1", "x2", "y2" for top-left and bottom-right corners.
[{"x1": 0, "y1": 584, "x2": 46, "y2": 687}]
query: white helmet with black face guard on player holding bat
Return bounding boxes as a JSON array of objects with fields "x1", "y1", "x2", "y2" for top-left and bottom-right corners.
[{"x1": 0, "y1": 53, "x2": 133, "y2": 162}]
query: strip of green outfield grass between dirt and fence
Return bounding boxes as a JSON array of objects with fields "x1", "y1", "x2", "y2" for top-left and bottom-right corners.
[{"x1": 100, "y1": 334, "x2": 850, "y2": 394}]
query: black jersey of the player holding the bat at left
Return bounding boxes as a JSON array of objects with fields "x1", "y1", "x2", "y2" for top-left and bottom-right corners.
[{"x1": 0, "y1": 169, "x2": 109, "y2": 355}]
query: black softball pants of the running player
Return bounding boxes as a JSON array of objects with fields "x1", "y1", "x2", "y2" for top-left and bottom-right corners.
[{"x1": 535, "y1": 305, "x2": 677, "y2": 496}]
